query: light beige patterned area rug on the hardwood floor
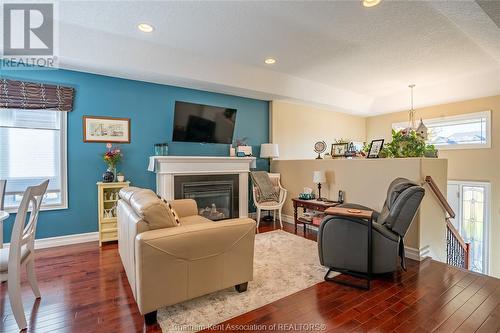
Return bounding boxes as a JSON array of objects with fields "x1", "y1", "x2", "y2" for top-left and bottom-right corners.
[{"x1": 158, "y1": 230, "x2": 326, "y2": 333}]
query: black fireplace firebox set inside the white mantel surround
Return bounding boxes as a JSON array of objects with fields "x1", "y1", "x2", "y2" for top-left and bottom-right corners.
[{"x1": 174, "y1": 174, "x2": 239, "y2": 221}]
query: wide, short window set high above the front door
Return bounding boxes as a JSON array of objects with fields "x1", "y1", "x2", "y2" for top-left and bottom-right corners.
[{"x1": 392, "y1": 111, "x2": 491, "y2": 149}]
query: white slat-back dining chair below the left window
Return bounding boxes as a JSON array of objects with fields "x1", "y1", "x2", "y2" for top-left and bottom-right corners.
[{"x1": 0, "y1": 180, "x2": 49, "y2": 330}]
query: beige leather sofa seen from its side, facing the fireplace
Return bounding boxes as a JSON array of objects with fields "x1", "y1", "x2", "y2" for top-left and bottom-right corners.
[{"x1": 117, "y1": 187, "x2": 255, "y2": 322}]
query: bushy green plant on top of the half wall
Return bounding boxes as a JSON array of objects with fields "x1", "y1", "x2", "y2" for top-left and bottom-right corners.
[{"x1": 383, "y1": 128, "x2": 437, "y2": 158}]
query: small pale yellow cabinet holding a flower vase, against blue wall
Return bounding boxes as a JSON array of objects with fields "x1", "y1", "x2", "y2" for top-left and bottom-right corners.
[{"x1": 97, "y1": 182, "x2": 130, "y2": 246}]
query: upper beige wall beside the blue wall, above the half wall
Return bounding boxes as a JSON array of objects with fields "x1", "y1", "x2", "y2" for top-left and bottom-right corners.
[{"x1": 271, "y1": 101, "x2": 366, "y2": 159}]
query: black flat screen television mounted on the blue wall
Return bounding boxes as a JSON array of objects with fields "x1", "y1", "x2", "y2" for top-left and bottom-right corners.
[{"x1": 172, "y1": 101, "x2": 236, "y2": 144}]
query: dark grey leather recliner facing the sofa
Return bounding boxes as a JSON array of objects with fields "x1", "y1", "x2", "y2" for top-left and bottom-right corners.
[{"x1": 318, "y1": 178, "x2": 425, "y2": 279}]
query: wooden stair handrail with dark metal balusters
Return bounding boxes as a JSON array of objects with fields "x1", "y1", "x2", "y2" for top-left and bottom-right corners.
[{"x1": 425, "y1": 176, "x2": 470, "y2": 269}]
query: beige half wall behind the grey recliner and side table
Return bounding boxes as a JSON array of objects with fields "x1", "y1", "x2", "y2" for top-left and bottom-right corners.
[{"x1": 271, "y1": 158, "x2": 447, "y2": 261}]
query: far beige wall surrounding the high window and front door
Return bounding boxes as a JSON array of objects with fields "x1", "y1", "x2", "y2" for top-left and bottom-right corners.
[{"x1": 366, "y1": 96, "x2": 500, "y2": 277}]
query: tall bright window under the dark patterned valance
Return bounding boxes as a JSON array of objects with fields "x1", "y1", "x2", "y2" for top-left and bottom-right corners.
[{"x1": 0, "y1": 109, "x2": 67, "y2": 211}]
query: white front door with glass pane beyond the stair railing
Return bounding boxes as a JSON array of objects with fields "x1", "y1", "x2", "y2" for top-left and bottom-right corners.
[{"x1": 447, "y1": 181, "x2": 490, "y2": 274}]
